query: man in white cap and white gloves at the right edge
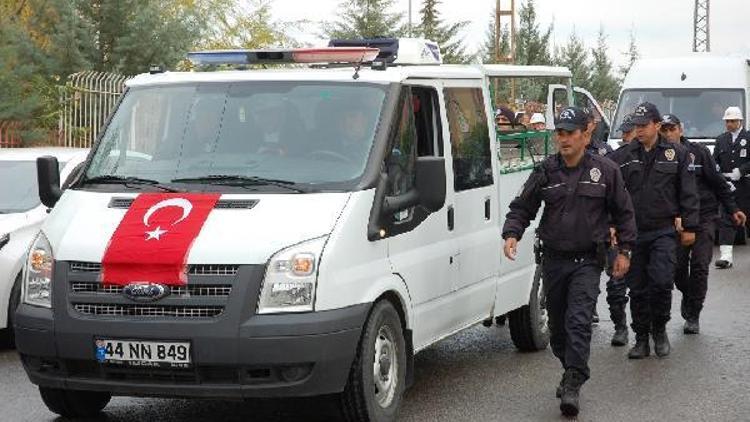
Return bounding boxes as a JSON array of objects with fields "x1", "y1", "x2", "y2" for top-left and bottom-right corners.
[{"x1": 714, "y1": 107, "x2": 750, "y2": 269}]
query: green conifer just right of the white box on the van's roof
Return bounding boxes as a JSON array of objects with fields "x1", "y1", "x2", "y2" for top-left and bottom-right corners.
[{"x1": 417, "y1": 0, "x2": 474, "y2": 63}]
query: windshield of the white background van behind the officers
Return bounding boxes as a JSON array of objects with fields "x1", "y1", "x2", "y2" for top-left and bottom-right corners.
[{"x1": 612, "y1": 89, "x2": 745, "y2": 139}]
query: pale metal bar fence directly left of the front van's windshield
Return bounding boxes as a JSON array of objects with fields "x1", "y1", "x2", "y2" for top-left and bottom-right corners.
[{"x1": 58, "y1": 71, "x2": 129, "y2": 148}]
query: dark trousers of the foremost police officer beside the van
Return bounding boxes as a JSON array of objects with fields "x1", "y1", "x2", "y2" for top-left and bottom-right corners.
[{"x1": 542, "y1": 257, "x2": 602, "y2": 379}]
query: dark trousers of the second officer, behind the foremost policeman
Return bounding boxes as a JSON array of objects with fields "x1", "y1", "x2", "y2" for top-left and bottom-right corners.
[{"x1": 625, "y1": 228, "x2": 677, "y2": 335}]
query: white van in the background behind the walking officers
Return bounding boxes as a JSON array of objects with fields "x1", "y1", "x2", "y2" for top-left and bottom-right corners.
[{"x1": 610, "y1": 53, "x2": 750, "y2": 146}]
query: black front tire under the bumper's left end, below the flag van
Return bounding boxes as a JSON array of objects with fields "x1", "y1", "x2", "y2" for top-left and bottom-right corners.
[{"x1": 39, "y1": 387, "x2": 112, "y2": 418}]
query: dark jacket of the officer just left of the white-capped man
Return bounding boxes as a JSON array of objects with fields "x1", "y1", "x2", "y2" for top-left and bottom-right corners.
[{"x1": 680, "y1": 137, "x2": 739, "y2": 222}]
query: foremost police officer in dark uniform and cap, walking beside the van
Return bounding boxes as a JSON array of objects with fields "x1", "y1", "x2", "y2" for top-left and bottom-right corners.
[{"x1": 503, "y1": 108, "x2": 635, "y2": 416}]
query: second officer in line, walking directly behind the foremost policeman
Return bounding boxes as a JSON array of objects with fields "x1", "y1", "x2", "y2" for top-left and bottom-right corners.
[{"x1": 611, "y1": 103, "x2": 699, "y2": 359}]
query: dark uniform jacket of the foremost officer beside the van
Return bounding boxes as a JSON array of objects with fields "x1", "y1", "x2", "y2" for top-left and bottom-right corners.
[{"x1": 503, "y1": 154, "x2": 636, "y2": 252}]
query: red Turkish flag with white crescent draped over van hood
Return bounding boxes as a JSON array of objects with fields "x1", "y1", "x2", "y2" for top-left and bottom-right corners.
[{"x1": 102, "y1": 193, "x2": 221, "y2": 286}]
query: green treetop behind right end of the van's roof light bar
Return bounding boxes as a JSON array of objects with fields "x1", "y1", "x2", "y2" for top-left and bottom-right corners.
[{"x1": 324, "y1": 0, "x2": 404, "y2": 38}]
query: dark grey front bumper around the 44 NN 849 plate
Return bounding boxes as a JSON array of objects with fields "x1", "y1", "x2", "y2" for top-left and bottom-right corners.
[{"x1": 16, "y1": 304, "x2": 370, "y2": 399}]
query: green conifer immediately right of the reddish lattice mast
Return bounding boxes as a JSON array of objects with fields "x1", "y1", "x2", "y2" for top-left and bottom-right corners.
[{"x1": 515, "y1": 0, "x2": 552, "y2": 65}]
